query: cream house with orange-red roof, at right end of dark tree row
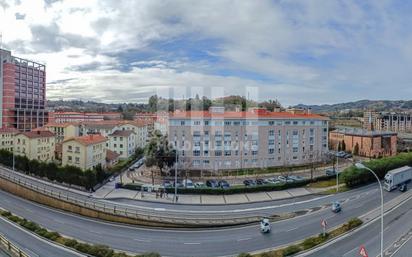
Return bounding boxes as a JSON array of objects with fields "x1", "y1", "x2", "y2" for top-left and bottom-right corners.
[{"x1": 62, "y1": 134, "x2": 108, "y2": 170}]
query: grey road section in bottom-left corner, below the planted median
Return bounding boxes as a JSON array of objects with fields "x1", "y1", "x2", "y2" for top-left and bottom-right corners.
[{"x1": 0, "y1": 218, "x2": 83, "y2": 257}]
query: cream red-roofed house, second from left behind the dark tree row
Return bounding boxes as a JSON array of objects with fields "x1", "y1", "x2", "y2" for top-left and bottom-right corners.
[{"x1": 14, "y1": 130, "x2": 55, "y2": 162}]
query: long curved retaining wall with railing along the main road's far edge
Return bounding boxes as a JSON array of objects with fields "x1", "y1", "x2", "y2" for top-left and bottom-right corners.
[{"x1": 0, "y1": 168, "x2": 261, "y2": 226}]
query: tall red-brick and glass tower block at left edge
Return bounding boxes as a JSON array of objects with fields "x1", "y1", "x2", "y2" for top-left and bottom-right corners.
[{"x1": 0, "y1": 49, "x2": 47, "y2": 131}]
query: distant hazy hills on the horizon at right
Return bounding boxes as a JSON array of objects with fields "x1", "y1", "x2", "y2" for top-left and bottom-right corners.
[{"x1": 293, "y1": 100, "x2": 412, "y2": 113}]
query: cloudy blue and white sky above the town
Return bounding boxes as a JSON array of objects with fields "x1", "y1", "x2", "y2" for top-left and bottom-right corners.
[{"x1": 0, "y1": 0, "x2": 412, "y2": 105}]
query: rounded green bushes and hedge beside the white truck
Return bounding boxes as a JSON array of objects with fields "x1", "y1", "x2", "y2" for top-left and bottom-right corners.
[{"x1": 342, "y1": 153, "x2": 412, "y2": 187}]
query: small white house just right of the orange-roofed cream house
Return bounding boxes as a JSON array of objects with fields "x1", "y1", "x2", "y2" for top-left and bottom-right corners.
[{"x1": 108, "y1": 130, "x2": 136, "y2": 159}]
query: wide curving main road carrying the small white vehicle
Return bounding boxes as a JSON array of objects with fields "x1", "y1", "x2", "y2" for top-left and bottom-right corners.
[{"x1": 0, "y1": 182, "x2": 399, "y2": 257}]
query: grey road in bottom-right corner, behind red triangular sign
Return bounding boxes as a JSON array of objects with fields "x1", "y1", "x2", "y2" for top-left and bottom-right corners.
[{"x1": 300, "y1": 199, "x2": 412, "y2": 257}]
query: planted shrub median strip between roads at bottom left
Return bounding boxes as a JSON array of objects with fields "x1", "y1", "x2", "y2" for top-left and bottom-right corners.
[{"x1": 0, "y1": 210, "x2": 160, "y2": 257}]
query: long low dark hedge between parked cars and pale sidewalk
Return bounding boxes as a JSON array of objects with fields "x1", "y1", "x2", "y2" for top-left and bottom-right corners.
[{"x1": 121, "y1": 176, "x2": 334, "y2": 195}]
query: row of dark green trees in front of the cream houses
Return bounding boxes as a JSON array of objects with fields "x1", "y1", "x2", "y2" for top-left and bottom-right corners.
[{"x1": 0, "y1": 150, "x2": 109, "y2": 190}]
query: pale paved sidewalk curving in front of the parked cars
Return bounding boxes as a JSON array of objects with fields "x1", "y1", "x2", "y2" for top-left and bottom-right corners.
[{"x1": 93, "y1": 176, "x2": 335, "y2": 205}]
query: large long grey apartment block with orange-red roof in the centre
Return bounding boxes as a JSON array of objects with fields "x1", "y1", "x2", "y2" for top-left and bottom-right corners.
[{"x1": 168, "y1": 107, "x2": 328, "y2": 171}]
